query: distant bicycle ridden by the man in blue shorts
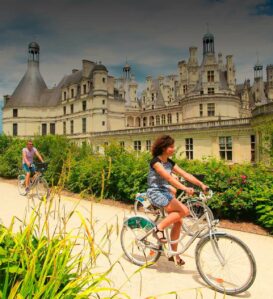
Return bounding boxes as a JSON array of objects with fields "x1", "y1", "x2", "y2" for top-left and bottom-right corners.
[{"x1": 18, "y1": 163, "x2": 49, "y2": 199}]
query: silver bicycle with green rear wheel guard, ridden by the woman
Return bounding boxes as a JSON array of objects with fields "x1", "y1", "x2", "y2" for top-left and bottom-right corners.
[{"x1": 121, "y1": 192, "x2": 256, "y2": 295}]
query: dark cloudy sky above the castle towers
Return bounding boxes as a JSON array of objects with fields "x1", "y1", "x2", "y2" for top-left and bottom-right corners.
[{"x1": 0, "y1": 0, "x2": 273, "y2": 98}]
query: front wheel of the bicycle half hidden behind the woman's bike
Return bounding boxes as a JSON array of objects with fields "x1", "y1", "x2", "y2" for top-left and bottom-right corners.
[{"x1": 182, "y1": 199, "x2": 214, "y2": 238}]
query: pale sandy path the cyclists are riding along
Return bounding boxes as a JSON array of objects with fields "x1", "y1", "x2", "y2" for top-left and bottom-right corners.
[{"x1": 0, "y1": 180, "x2": 273, "y2": 299}]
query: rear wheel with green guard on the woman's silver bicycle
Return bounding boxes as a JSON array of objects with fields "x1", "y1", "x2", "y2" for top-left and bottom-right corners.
[{"x1": 120, "y1": 216, "x2": 161, "y2": 266}]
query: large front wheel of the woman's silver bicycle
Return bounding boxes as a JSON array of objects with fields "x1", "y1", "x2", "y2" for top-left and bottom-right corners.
[{"x1": 195, "y1": 233, "x2": 256, "y2": 295}]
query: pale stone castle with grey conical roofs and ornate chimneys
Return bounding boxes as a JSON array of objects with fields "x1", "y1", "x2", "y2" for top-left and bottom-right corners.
[{"x1": 3, "y1": 33, "x2": 273, "y2": 163}]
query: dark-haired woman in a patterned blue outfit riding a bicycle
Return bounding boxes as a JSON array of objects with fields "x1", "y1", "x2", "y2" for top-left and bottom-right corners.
[{"x1": 147, "y1": 135, "x2": 208, "y2": 265}]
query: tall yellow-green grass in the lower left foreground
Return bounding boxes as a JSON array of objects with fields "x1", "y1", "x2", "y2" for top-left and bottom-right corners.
[{"x1": 0, "y1": 158, "x2": 131, "y2": 299}]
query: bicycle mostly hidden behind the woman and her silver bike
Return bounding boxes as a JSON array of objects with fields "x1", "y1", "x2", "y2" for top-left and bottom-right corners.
[{"x1": 134, "y1": 190, "x2": 214, "y2": 238}]
